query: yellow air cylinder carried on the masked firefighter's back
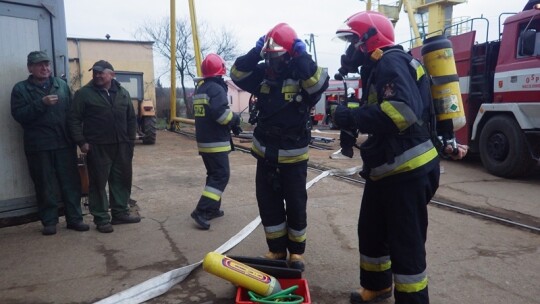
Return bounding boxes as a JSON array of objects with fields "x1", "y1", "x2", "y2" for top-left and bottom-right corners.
[{"x1": 422, "y1": 35, "x2": 466, "y2": 131}]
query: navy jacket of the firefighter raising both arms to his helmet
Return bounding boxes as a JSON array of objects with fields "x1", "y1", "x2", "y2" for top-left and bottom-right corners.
[{"x1": 231, "y1": 49, "x2": 329, "y2": 164}]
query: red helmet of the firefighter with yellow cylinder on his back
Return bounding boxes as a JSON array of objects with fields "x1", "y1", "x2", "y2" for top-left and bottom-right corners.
[{"x1": 336, "y1": 11, "x2": 394, "y2": 53}]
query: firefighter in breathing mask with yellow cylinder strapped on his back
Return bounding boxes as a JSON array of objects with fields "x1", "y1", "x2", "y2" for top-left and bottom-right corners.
[{"x1": 333, "y1": 11, "x2": 467, "y2": 304}]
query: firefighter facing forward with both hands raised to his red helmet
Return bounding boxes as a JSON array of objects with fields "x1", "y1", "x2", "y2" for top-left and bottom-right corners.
[{"x1": 231, "y1": 23, "x2": 329, "y2": 270}]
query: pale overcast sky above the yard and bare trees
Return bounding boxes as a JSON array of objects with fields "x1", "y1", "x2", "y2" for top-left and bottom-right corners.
[{"x1": 64, "y1": 0, "x2": 527, "y2": 83}]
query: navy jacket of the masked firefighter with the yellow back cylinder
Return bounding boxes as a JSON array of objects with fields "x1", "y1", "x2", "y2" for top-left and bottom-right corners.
[{"x1": 352, "y1": 47, "x2": 438, "y2": 180}]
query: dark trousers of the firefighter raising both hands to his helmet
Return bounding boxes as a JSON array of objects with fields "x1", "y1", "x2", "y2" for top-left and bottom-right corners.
[{"x1": 255, "y1": 160, "x2": 307, "y2": 254}]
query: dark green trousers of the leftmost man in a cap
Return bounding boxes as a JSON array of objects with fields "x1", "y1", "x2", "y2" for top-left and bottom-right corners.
[{"x1": 26, "y1": 147, "x2": 82, "y2": 226}]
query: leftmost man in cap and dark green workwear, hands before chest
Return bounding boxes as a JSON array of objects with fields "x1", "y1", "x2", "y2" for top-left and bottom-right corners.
[{"x1": 11, "y1": 51, "x2": 89, "y2": 235}]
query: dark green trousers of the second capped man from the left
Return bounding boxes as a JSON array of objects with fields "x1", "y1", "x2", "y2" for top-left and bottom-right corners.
[{"x1": 86, "y1": 142, "x2": 133, "y2": 224}]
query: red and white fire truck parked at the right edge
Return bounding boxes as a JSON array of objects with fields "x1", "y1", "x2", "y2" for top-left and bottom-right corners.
[{"x1": 411, "y1": 5, "x2": 540, "y2": 178}]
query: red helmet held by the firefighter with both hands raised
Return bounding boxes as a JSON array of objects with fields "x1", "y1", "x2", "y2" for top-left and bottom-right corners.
[{"x1": 261, "y1": 23, "x2": 298, "y2": 57}]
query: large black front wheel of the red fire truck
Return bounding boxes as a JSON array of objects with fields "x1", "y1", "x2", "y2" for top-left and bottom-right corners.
[{"x1": 480, "y1": 116, "x2": 536, "y2": 178}]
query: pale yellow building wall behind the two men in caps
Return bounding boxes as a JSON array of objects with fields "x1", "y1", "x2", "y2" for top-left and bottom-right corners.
[{"x1": 67, "y1": 38, "x2": 156, "y2": 101}]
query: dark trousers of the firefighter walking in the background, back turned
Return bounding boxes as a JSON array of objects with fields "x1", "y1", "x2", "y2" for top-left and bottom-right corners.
[{"x1": 196, "y1": 152, "x2": 231, "y2": 213}]
